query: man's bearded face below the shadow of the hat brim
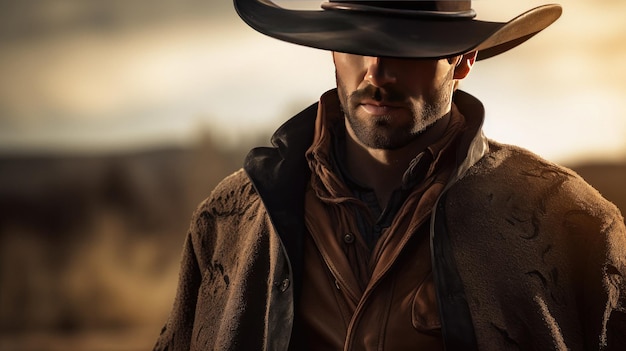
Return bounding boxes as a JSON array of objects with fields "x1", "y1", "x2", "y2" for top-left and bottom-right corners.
[{"x1": 333, "y1": 52, "x2": 457, "y2": 150}]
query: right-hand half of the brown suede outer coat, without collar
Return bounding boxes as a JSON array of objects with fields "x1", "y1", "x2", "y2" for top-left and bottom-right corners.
[{"x1": 445, "y1": 143, "x2": 626, "y2": 350}]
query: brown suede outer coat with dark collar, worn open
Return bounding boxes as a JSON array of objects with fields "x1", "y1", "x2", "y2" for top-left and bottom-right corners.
[{"x1": 155, "y1": 93, "x2": 626, "y2": 350}]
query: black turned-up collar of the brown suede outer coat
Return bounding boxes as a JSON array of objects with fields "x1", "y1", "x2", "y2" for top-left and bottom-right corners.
[{"x1": 244, "y1": 90, "x2": 487, "y2": 302}]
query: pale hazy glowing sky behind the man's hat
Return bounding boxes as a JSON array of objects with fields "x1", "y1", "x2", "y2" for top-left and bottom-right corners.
[{"x1": 0, "y1": 0, "x2": 626, "y2": 164}]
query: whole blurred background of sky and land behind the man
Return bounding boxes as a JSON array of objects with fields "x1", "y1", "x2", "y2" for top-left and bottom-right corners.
[{"x1": 0, "y1": 0, "x2": 626, "y2": 350}]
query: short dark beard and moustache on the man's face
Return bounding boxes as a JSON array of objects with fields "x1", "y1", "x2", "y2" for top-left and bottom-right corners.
[{"x1": 335, "y1": 74, "x2": 453, "y2": 150}]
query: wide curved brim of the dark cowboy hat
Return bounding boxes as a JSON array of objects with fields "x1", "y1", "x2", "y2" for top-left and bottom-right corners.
[{"x1": 234, "y1": 0, "x2": 562, "y2": 60}]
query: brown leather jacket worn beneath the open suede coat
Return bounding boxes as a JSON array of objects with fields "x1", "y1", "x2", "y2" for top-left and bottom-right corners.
[{"x1": 296, "y1": 90, "x2": 464, "y2": 350}]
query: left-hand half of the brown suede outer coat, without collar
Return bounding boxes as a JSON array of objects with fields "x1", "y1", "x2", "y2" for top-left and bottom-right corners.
[{"x1": 155, "y1": 171, "x2": 293, "y2": 350}]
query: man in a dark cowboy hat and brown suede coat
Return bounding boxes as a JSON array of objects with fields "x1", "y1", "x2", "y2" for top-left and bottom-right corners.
[{"x1": 156, "y1": 0, "x2": 626, "y2": 350}]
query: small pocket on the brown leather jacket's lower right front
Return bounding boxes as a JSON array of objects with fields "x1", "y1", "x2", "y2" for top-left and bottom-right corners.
[{"x1": 411, "y1": 272, "x2": 441, "y2": 333}]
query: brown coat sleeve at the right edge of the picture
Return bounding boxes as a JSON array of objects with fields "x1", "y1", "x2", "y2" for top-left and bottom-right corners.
[{"x1": 561, "y1": 177, "x2": 626, "y2": 351}]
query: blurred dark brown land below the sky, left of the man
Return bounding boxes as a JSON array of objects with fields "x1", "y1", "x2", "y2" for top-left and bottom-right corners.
[{"x1": 0, "y1": 144, "x2": 247, "y2": 350}]
